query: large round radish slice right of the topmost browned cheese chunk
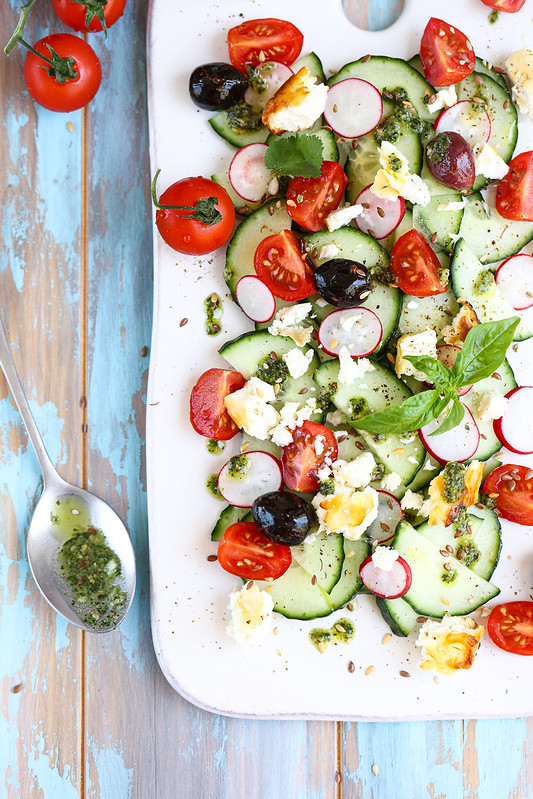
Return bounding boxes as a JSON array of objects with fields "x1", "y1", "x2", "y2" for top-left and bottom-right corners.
[{"x1": 324, "y1": 78, "x2": 383, "y2": 139}]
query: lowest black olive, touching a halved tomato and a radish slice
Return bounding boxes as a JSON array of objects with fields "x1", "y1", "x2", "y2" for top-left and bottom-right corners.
[{"x1": 252, "y1": 491, "x2": 317, "y2": 546}]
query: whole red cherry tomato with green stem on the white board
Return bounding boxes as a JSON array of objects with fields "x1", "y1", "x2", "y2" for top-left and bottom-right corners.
[{"x1": 154, "y1": 177, "x2": 235, "y2": 255}]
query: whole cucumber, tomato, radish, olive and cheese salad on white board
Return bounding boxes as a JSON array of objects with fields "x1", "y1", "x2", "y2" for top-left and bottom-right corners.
[{"x1": 153, "y1": 18, "x2": 533, "y2": 673}]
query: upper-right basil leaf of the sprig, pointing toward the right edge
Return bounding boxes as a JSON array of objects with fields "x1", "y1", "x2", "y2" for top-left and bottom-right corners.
[{"x1": 451, "y1": 316, "x2": 520, "y2": 388}]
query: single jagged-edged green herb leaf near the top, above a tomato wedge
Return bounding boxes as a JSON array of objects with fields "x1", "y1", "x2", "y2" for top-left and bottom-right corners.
[{"x1": 265, "y1": 133, "x2": 324, "y2": 178}]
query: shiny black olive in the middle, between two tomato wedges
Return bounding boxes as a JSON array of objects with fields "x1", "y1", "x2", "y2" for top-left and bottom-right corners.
[{"x1": 315, "y1": 258, "x2": 372, "y2": 308}]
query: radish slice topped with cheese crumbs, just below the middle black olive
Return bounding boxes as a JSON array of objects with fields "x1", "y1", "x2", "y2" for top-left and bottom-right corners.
[{"x1": 318, "y1": 307, "x2": 383, "y2": 358}]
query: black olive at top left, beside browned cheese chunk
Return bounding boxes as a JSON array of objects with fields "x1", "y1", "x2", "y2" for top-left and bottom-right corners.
[{"x1": 189, "y1": 61, "x2": 248, "y2": 111}]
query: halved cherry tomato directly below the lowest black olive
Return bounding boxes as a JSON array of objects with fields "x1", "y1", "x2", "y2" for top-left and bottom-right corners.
[{"x1": 217, "y1": 522, "x2": 292, "y2": 580}]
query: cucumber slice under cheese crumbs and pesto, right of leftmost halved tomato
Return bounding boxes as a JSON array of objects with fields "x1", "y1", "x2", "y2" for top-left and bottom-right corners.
[{"x1": 219, "y1": 330, "x2": 319, "y2": 405}]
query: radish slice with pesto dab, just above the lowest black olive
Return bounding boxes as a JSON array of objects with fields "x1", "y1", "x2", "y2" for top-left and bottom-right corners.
[{"x1": 218, "y1": 451, "x2": 283, "y2": 508}]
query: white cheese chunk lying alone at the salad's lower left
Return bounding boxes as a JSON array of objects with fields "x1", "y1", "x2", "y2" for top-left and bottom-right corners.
[{"x1": 226, "y1": 582, "x2": 274, "y2": 647}]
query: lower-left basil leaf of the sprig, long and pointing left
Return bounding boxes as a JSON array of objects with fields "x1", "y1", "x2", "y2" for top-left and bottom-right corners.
[{"x1": 353, "y1": 388, "x2": 442, "y2": 433}]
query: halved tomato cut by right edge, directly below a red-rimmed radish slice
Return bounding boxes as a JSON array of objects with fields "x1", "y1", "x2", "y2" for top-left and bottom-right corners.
[{"x1": 483, "y1": 463, "x2": 533, "y2": 526}]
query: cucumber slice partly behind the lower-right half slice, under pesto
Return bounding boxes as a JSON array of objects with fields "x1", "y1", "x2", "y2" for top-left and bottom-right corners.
[{"x1": 416, "y1": 507, "x2": 502, "y2": 580}]
